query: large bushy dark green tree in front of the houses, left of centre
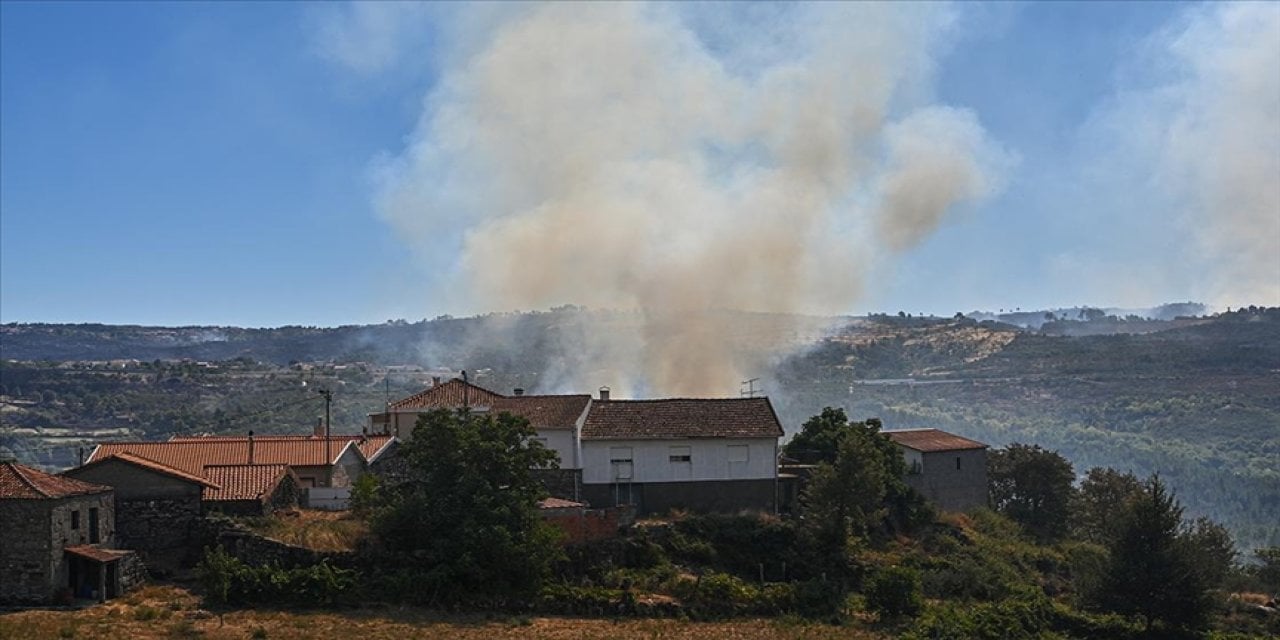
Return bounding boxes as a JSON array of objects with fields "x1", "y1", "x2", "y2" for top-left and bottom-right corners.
[{"x1": 360, "y1": 410, "x2": 561, "y2": 602}]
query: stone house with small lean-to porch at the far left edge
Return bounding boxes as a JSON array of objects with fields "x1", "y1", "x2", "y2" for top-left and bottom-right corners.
[{"x1": 0, "y1": 462, "x2": 145, "y2": 604}]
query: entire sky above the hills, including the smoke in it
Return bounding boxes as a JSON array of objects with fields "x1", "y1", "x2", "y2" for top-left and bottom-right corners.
[{"x1": 0, "y1": 1, "x2": 1280, "y2": 326}]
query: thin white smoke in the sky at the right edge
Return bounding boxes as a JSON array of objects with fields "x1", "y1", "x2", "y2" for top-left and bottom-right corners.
[{"x1": 1076, "y1": 3, "x2": 1280, "y2": 308}]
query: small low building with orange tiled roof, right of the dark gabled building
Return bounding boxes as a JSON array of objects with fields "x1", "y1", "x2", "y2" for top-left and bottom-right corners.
[{"x1": 202, "y1": 465, "x2": 302, "y2": 516}]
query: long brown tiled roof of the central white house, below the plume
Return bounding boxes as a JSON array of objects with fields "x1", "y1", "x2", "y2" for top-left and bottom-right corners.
[{"x1": 582, "y1": 398, "x2": 782, "y2": 440}]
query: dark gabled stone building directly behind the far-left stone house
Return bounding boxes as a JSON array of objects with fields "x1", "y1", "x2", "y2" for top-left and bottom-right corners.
[{"x1": 63, "y1": 452, "x2": 216, "y2": 573}]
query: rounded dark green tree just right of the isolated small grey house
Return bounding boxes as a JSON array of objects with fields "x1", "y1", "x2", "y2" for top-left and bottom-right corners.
[{"x1": 987, "y1": 443, "x2": 1075, "y2": 541}]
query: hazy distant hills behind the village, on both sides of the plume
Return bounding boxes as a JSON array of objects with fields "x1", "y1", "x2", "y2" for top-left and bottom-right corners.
[{"x1": 0, "y1": 305, "x2": 1280, "y2": 547}]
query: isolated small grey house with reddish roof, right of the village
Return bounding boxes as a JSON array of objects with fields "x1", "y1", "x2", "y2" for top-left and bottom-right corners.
[{"x1": 881, "y1": 429, "x2": 988, "y2": 511}]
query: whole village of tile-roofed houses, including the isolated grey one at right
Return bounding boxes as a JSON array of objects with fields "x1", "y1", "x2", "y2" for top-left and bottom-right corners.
[{"x1": 0, "y1": 372, "x2": 987, "y2": 604}]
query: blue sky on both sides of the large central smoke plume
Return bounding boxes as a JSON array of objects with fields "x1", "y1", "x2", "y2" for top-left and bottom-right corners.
[{"x1": 0, "y1": 1, "x2": 1280, "y2": 326}]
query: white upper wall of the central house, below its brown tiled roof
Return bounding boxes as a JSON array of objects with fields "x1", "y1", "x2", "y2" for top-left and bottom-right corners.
[{"x1": 582, "y1": 438, "x2": 778, "y2": 484}]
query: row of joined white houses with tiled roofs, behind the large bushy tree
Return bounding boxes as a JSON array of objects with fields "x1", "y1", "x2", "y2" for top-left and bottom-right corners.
[{"x1": 370, "y1": 379, "x2": 782, "y2": 512}]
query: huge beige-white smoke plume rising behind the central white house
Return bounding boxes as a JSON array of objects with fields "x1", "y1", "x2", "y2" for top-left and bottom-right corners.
[{"x1": 366, "y1": 3, "x2": 1007, "y2": 396}]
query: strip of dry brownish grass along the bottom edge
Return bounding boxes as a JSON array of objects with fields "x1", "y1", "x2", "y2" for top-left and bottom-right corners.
[{"x1": 0, "y1": 586, "x2": 888, "y2": 640}]
